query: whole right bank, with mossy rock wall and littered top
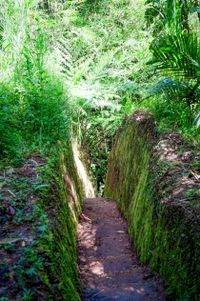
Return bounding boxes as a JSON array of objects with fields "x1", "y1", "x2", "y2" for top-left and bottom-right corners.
[{"x1": 105, "y1": 111, "x2": 200, "y2": 300}]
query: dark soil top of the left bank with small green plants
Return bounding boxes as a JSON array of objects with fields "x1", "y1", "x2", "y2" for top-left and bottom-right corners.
[{"x1": 0, "y1": 154, "x2": 46, "y2": 301}]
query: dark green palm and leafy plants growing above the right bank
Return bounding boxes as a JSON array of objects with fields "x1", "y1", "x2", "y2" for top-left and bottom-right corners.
[{"x1": 146, "y1": 0, "x2": 200, "y2": 132}]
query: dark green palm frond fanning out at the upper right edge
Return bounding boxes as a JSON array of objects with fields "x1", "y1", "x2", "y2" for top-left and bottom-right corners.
[{"x1": 151, "y1": 32, "x2": 200, "y2": 80}]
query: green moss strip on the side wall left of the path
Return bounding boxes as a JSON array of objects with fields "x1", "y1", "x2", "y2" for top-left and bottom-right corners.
[{"x1": 38, "y1": 144, "x2": 82, "y2": 301}]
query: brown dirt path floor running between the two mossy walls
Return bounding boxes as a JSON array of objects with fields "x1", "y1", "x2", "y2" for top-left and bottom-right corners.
[{"x1": 78, "y1": 198, "x2": 166, "y2": 301}]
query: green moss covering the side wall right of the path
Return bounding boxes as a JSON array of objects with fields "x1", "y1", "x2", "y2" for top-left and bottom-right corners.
[{"x1": 105, "y1": 112, "x2": 200, "y2": 301}]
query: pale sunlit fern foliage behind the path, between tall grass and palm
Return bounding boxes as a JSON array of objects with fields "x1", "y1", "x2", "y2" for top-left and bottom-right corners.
[{"x1": 59, "y1": 0, "x2": 151, "y2": 193}]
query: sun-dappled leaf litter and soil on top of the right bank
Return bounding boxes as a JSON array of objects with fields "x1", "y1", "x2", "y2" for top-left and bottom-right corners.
[{"x1": 154, "y1": 133, "x2": 200, "y2": 209}]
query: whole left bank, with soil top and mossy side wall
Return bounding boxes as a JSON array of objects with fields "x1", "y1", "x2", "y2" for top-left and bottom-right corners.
[{"x1": 0, "y1": 145, "x2": 83, "y2": 301}]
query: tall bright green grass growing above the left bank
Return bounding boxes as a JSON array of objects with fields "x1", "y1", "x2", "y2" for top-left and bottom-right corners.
[{"x1": 0, "y1": 0, "x2": 70, "y2": 162}]
